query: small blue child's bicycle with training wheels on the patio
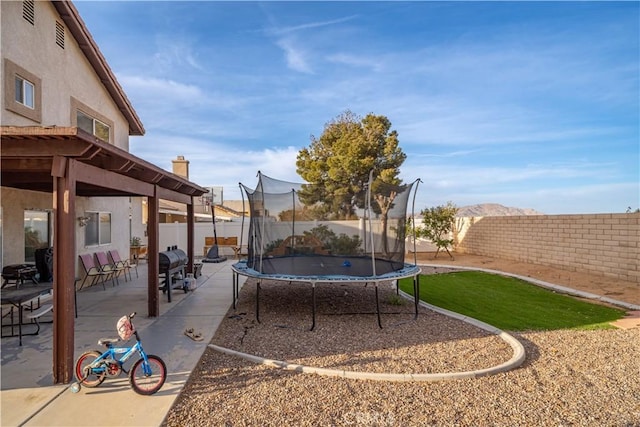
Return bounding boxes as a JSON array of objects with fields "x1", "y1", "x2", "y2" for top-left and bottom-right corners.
[{"x1": 71, "y1": 312, "x2": 167, "y2": 395}]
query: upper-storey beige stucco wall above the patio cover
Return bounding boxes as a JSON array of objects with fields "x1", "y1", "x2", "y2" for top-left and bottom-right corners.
[{"x1": 0, "y1": 1, "x2": 129, "y2": 151}]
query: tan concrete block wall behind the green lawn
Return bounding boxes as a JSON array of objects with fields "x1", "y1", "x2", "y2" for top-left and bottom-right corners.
[{"x1": 454, "y1": 213, "x2": 640, "y2": 283}]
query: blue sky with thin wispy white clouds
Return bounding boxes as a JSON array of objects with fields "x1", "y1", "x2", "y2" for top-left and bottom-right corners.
[{"x1": 75, "y1": 1, "x2": 640, "y2": 214}]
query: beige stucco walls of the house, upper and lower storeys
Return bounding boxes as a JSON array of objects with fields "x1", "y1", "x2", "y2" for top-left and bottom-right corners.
[{"x1": 0, "y1": 1, "x2": 136, "y2": 268}]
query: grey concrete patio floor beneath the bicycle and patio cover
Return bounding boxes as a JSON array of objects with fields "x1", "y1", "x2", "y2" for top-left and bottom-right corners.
[{"x1": 0, "y1": 260, "x2": 242, "y2": 426}]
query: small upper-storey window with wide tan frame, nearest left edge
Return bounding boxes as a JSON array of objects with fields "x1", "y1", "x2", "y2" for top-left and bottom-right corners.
[{"x1": 4, "y1": 58, "x2": 42, "y2": 123}]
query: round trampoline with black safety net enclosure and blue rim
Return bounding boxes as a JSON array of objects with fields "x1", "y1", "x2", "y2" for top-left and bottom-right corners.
[{"x1": 232, "y1": 172, "x2": 421, "y2": 330}]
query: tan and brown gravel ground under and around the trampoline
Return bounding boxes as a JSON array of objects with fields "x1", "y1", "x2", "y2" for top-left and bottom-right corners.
[{"x1": 164, "y1": 274, "x2": 640, "y2": 426}]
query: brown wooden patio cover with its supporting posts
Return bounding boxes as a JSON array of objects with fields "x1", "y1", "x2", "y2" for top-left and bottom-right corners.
[{"x1": 0, "y1": 126, "x2": 208, "y2": 384}]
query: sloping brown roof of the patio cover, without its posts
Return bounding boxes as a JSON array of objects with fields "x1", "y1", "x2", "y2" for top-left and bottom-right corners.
[{"x1": 0, "y1": 126, "x2": 208, "y2": 204}]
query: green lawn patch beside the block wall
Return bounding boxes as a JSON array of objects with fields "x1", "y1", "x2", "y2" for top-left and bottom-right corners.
[{"x1": 400, "y1": 271, "x2": 625, "y2": 331}]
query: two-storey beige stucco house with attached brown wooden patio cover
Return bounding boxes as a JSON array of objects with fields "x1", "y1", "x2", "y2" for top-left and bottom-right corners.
[{"x1": 0, "y1": 0, "x2": 207, "y2": 383}]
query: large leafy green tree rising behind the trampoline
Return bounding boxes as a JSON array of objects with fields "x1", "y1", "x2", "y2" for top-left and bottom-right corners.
[{"x1": 296, "y1": 110, "x2": 406, "y2": 252}]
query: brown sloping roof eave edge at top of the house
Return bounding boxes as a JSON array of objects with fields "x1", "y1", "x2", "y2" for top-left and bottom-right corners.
[{"x1": 51, "y1": 1, "x2": 145, "y2": 135}]
